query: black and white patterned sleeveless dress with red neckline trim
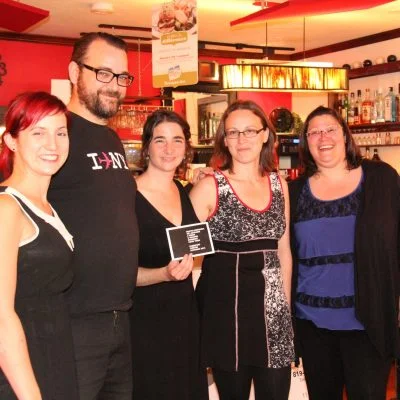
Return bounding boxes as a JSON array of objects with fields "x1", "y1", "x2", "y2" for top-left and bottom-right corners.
[{"x1": 197, "y1": 171, "x2": 294, "y2": 371}]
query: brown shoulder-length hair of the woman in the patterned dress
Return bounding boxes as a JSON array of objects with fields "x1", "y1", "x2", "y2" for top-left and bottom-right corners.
[{"x1": 212, "y1": 100, "x2": 276, "y2": 175}]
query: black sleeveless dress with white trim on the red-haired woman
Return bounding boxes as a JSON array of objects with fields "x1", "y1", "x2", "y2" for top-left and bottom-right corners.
[{"x1": 0, "y1": 186, "x2": 79, "y2": 400}]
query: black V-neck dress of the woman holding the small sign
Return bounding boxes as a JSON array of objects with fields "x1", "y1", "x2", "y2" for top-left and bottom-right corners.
[{"x1": 130, "y1": 181, "x2": 208, "y2": 400}]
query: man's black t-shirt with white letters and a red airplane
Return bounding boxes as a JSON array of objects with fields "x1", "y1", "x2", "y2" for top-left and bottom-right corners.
[{"x1": 48, "y1": 113, "x2": 138, "y2": 314}]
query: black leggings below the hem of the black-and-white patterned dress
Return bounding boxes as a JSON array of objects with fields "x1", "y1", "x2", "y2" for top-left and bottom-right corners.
[{"x1": 213, "y1": 366, "x2": 290, "y2": 400}]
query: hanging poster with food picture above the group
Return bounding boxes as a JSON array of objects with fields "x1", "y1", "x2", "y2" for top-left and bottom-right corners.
[{"x1": 152, "y1": 0, "x2": 198, "y2": 88}]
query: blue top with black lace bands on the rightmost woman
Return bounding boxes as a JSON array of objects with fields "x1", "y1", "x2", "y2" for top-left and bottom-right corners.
[{"x1": 294, "y1": 179, "x2": 364, "y2": 330}]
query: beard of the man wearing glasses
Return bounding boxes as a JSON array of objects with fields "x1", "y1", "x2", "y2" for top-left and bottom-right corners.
[{"x1": 77, "y1": 77, "x2": 124, "y2": 119}]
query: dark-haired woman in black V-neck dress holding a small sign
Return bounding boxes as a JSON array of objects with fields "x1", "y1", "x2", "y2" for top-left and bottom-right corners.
[{"x1": 130, "y1": 110, "x2": 208, "y2": 400}]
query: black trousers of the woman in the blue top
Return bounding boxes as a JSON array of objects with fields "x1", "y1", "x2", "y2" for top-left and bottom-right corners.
[{"x1": 296, "y1": 319, "x2": 392, "y2": 400}]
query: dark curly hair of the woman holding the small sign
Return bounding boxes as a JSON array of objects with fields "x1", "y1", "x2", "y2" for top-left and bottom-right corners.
[{"x1": 140, "y1": 109, "x2": 193, "y2": 172}]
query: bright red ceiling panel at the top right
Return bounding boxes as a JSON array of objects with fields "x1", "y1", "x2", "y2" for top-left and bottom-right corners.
[{"x1": 230, "y1": 0, "x2": 394, "y2": 26}]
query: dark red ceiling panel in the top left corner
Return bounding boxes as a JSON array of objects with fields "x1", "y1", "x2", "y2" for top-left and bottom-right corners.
[{"x1": 0, "y1": 0, "x2": 49, "y2": 32}]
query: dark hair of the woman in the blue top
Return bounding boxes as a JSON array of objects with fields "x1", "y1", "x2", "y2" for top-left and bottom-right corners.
[{"x1": 299, "y1": 106, "x2": 362, "y2": 176}]
